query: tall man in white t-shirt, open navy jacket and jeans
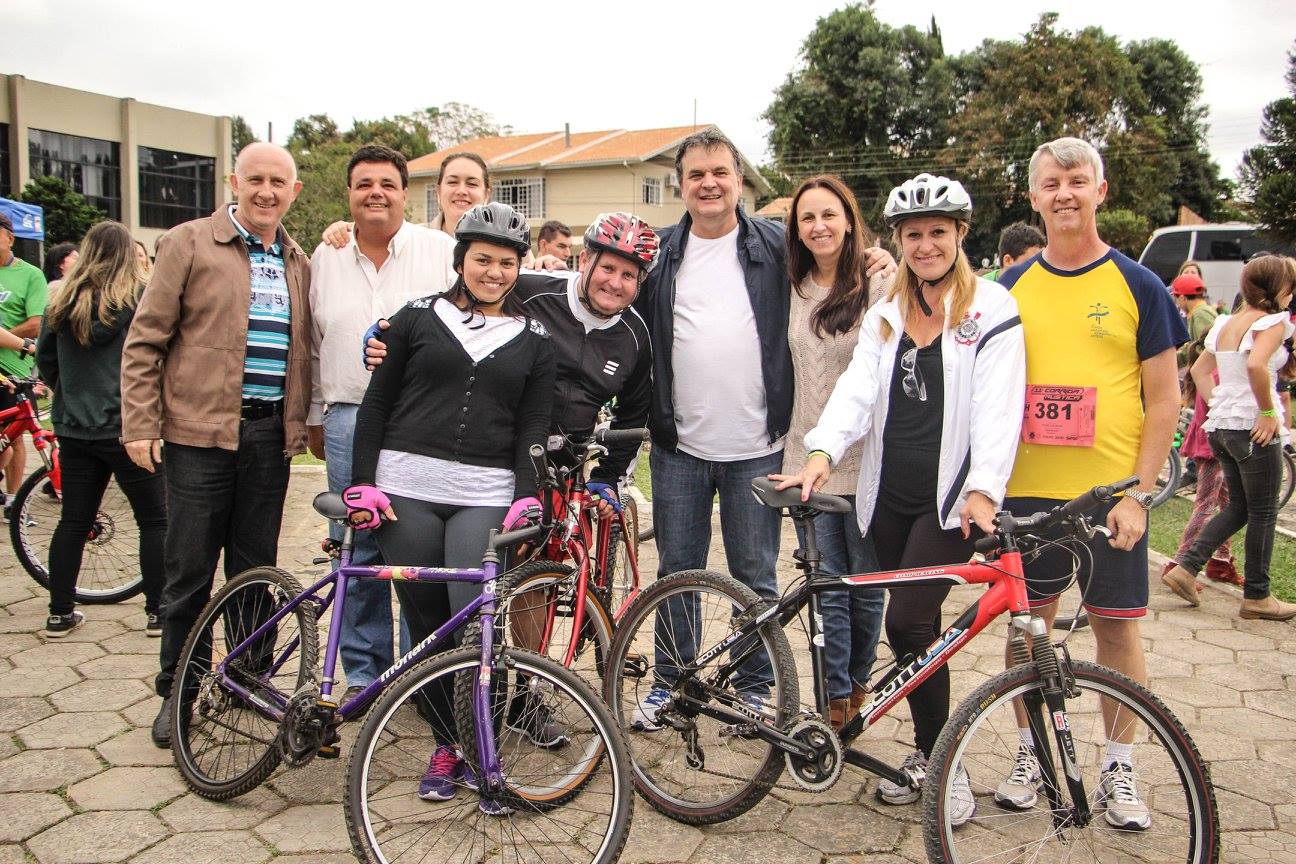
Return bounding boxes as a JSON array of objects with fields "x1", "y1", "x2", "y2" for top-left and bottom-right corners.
[{"x1": 635, "y1": 128, "x2": 894, "y2": 729}]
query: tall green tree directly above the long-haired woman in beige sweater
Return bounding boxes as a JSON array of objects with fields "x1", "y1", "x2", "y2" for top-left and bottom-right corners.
[{"x1": 763, "y1": 0, "x2": 955, "y2": 233}]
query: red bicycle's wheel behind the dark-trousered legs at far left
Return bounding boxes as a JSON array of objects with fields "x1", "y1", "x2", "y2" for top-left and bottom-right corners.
[{"x1": 9, "y1": 465, "x2": 144, "y2": 604}]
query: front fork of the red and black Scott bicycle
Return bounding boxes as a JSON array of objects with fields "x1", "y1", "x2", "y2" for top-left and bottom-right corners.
[{"x1": 1010, "y1": 615, "x2": 1093, "y2": 830}]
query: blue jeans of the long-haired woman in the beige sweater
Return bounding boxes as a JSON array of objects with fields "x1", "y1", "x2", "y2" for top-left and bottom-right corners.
[{"x1": 797, "y1": 495, "x2": 886, "y2": 699}]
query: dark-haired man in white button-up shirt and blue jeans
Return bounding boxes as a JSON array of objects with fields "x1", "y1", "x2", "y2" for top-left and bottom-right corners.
[{"x1": 306, "y1": 145, "x2": 455, "y2": 698}]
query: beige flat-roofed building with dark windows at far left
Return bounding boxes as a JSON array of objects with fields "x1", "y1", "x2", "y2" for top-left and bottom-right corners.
[{"x1": 0, "y1": 74, "x2": 233, "y2": 250}]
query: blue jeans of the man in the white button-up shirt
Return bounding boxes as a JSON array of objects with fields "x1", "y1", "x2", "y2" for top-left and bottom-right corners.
[{"x1": 324, "y1": 403, "x2": 408, "y2": 687}]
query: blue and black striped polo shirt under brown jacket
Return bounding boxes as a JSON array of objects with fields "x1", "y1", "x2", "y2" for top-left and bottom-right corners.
[{"x1": 229, "y1": 205, "x2": 293, "y2": 402}]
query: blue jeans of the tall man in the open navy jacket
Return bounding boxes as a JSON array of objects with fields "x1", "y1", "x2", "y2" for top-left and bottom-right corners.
[{"x1": 648, "y1": 447, "x2": 783, "y2": 692}]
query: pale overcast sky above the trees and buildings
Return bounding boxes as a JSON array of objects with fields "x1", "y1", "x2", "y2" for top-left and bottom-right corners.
[{"x1": 10, "y1": 0, "x2": 1296, "y2": 176}]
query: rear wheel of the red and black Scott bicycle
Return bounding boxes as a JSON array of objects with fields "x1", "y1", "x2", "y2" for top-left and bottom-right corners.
[{"x1": 604, "y1": 570, "x2": 800, "y2": 825}]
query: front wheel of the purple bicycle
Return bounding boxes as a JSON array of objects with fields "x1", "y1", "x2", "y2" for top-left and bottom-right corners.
[{"x1": 345, "y1": 648, "x2": 634, "y2": 864}]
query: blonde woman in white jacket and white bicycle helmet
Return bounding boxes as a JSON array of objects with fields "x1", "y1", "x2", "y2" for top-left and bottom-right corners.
[{"x1": 781, "y1": 174, "x2": 1025, "y2": 824}]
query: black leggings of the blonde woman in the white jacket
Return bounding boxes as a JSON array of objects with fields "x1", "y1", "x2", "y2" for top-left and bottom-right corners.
[{"x1": 870, "y1": 501, "x2": 978, "y2": 756}]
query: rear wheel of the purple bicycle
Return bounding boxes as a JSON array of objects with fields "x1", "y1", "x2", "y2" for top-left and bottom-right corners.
[{"x1": 171, "y1": 567, "x2": 319, "y2": 801}]
